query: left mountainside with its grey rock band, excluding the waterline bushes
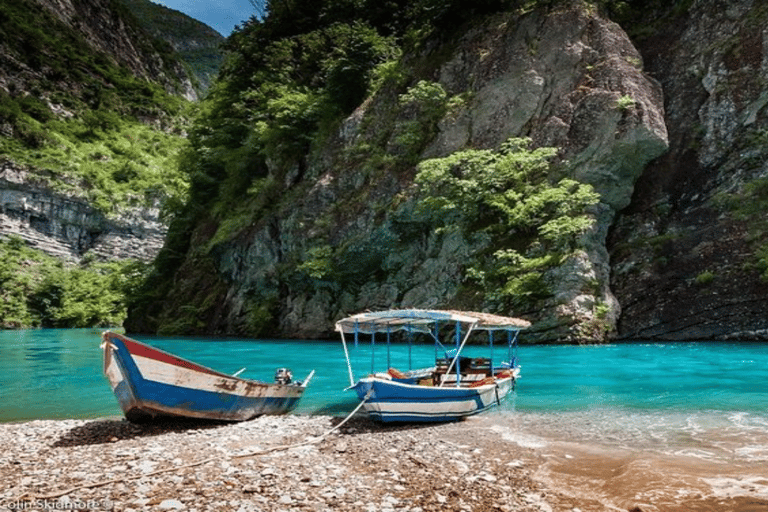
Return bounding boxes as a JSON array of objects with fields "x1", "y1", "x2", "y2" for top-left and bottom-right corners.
[{"x1": 0, "y1": 0, "x2": 195, "y2": 259}]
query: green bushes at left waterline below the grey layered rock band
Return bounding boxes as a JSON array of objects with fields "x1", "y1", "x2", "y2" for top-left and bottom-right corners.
[{"x1": 0, "y1": 237, "x2": 147, "y2": 329}]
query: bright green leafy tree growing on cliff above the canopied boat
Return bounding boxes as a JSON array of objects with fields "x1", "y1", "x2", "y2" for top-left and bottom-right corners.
[{"x1": 416, "y1": 139, "x2": 599, "y2": 309}]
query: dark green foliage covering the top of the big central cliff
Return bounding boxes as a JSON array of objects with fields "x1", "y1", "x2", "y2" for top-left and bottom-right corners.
[{"x1": 166, "y1": 0, "x2": 672, "y2": 229}]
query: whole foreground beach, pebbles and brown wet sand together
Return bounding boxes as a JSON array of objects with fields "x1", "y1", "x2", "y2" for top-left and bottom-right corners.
[{"x1": 0, "y1": 414, "x2": 768, "y2": 512}]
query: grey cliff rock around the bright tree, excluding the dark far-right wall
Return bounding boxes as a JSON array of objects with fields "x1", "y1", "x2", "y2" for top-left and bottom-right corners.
[{"x1": 142, "y1": 7, "x2": 667, "y2": 341}]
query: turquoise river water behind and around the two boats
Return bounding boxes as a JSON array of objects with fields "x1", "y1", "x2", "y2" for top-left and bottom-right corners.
[{"x1": 0, "y1": 329, "x2": 768, "y2": 421}]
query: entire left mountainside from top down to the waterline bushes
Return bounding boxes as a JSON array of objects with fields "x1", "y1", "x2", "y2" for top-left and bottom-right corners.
[{"x1": 0, "y1": 0, "x2": 196, "y2": 327}]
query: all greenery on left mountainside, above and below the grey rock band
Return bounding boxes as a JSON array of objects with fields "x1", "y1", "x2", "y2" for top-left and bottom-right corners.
[{"x1": 0, "y1": 0, "x2": 198, "y2": 328}]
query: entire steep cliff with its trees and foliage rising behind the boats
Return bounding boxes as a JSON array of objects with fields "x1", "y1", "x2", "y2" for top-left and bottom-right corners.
[{"x1": 126, "y1": 0, "x2": 768, "y2": 342}]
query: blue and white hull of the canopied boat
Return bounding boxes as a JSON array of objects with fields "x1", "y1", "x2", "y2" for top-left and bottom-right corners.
[{"x1": 352, "y1": 376, "x2": 515, "y2": 423}]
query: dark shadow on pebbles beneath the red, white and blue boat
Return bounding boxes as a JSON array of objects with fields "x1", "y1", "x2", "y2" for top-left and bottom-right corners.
[{"x1": 53, "y1": 419, "x2": 228, "y2": 448}]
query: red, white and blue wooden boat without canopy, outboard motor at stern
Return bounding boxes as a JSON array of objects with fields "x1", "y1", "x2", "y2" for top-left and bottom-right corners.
[{"x1": 101, "y1": 331, "x2": 314, "y2": 422}]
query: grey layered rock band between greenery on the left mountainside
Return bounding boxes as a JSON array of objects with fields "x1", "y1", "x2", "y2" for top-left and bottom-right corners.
[{"x1": 0, "y1": 162, "x2": 166, "y2": 262}]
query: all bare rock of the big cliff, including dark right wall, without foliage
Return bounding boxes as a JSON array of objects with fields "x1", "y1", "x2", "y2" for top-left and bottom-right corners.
[{"x1": 127, "y1": 0, "x2": 768, "y2": 341}]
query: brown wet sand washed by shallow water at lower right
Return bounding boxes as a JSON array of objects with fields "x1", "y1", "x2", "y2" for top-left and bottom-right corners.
[{"x1": 492, "y1": 412, "x2": 768, "y2": 512}]
